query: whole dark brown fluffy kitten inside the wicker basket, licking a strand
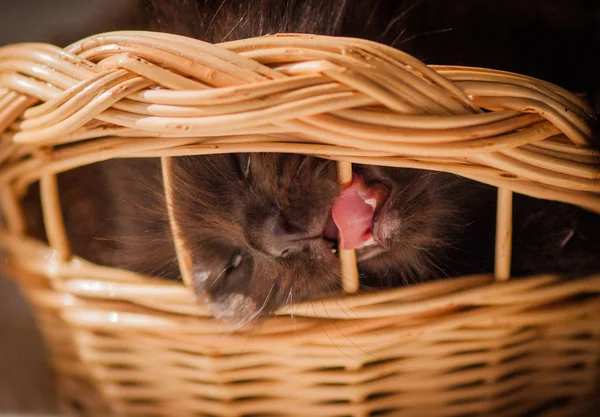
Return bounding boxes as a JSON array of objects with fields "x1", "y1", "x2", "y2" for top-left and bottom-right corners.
[{"x1": 25, "y1": 0, "x2": 600, "y2": 324}]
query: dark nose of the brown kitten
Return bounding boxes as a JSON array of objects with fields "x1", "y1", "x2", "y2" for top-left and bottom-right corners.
[{"x1": 263, "y1": 215, "x2": 308, "y2": 258}]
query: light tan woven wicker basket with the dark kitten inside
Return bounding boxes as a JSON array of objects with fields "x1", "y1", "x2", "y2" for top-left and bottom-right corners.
[{"x1": 0, "y1": 32, "x2": 600, "y2": 417}]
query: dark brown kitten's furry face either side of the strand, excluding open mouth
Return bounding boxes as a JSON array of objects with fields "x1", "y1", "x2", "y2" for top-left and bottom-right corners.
[{"x1": 172, "y1": 154, "x2": 468, "y2": 324}]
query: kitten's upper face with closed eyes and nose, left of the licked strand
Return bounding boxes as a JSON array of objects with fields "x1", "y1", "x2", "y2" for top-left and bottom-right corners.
[{"x1": 172, "y1": 154, "x2": 339, "y2": 322}]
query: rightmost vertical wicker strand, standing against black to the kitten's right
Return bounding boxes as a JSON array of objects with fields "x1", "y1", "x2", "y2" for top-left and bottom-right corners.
[{"x1": 494, "y1": 188, "x2": 512, "y2": 280}]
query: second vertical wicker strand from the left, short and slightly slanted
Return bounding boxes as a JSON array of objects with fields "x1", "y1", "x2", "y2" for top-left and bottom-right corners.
[{"x1": 40, "y1": 174, "x2": 71, "y2": 262}]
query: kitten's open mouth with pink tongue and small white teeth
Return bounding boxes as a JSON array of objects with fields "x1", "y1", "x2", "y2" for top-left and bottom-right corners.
[{"x1": 323, "y1": 174, "x2": 388, "y2": 249}]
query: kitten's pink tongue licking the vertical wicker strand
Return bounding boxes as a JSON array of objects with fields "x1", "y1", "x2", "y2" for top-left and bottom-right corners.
[{"x1": 331, "y1": 176, "x2": 375, "y2": 249}]
